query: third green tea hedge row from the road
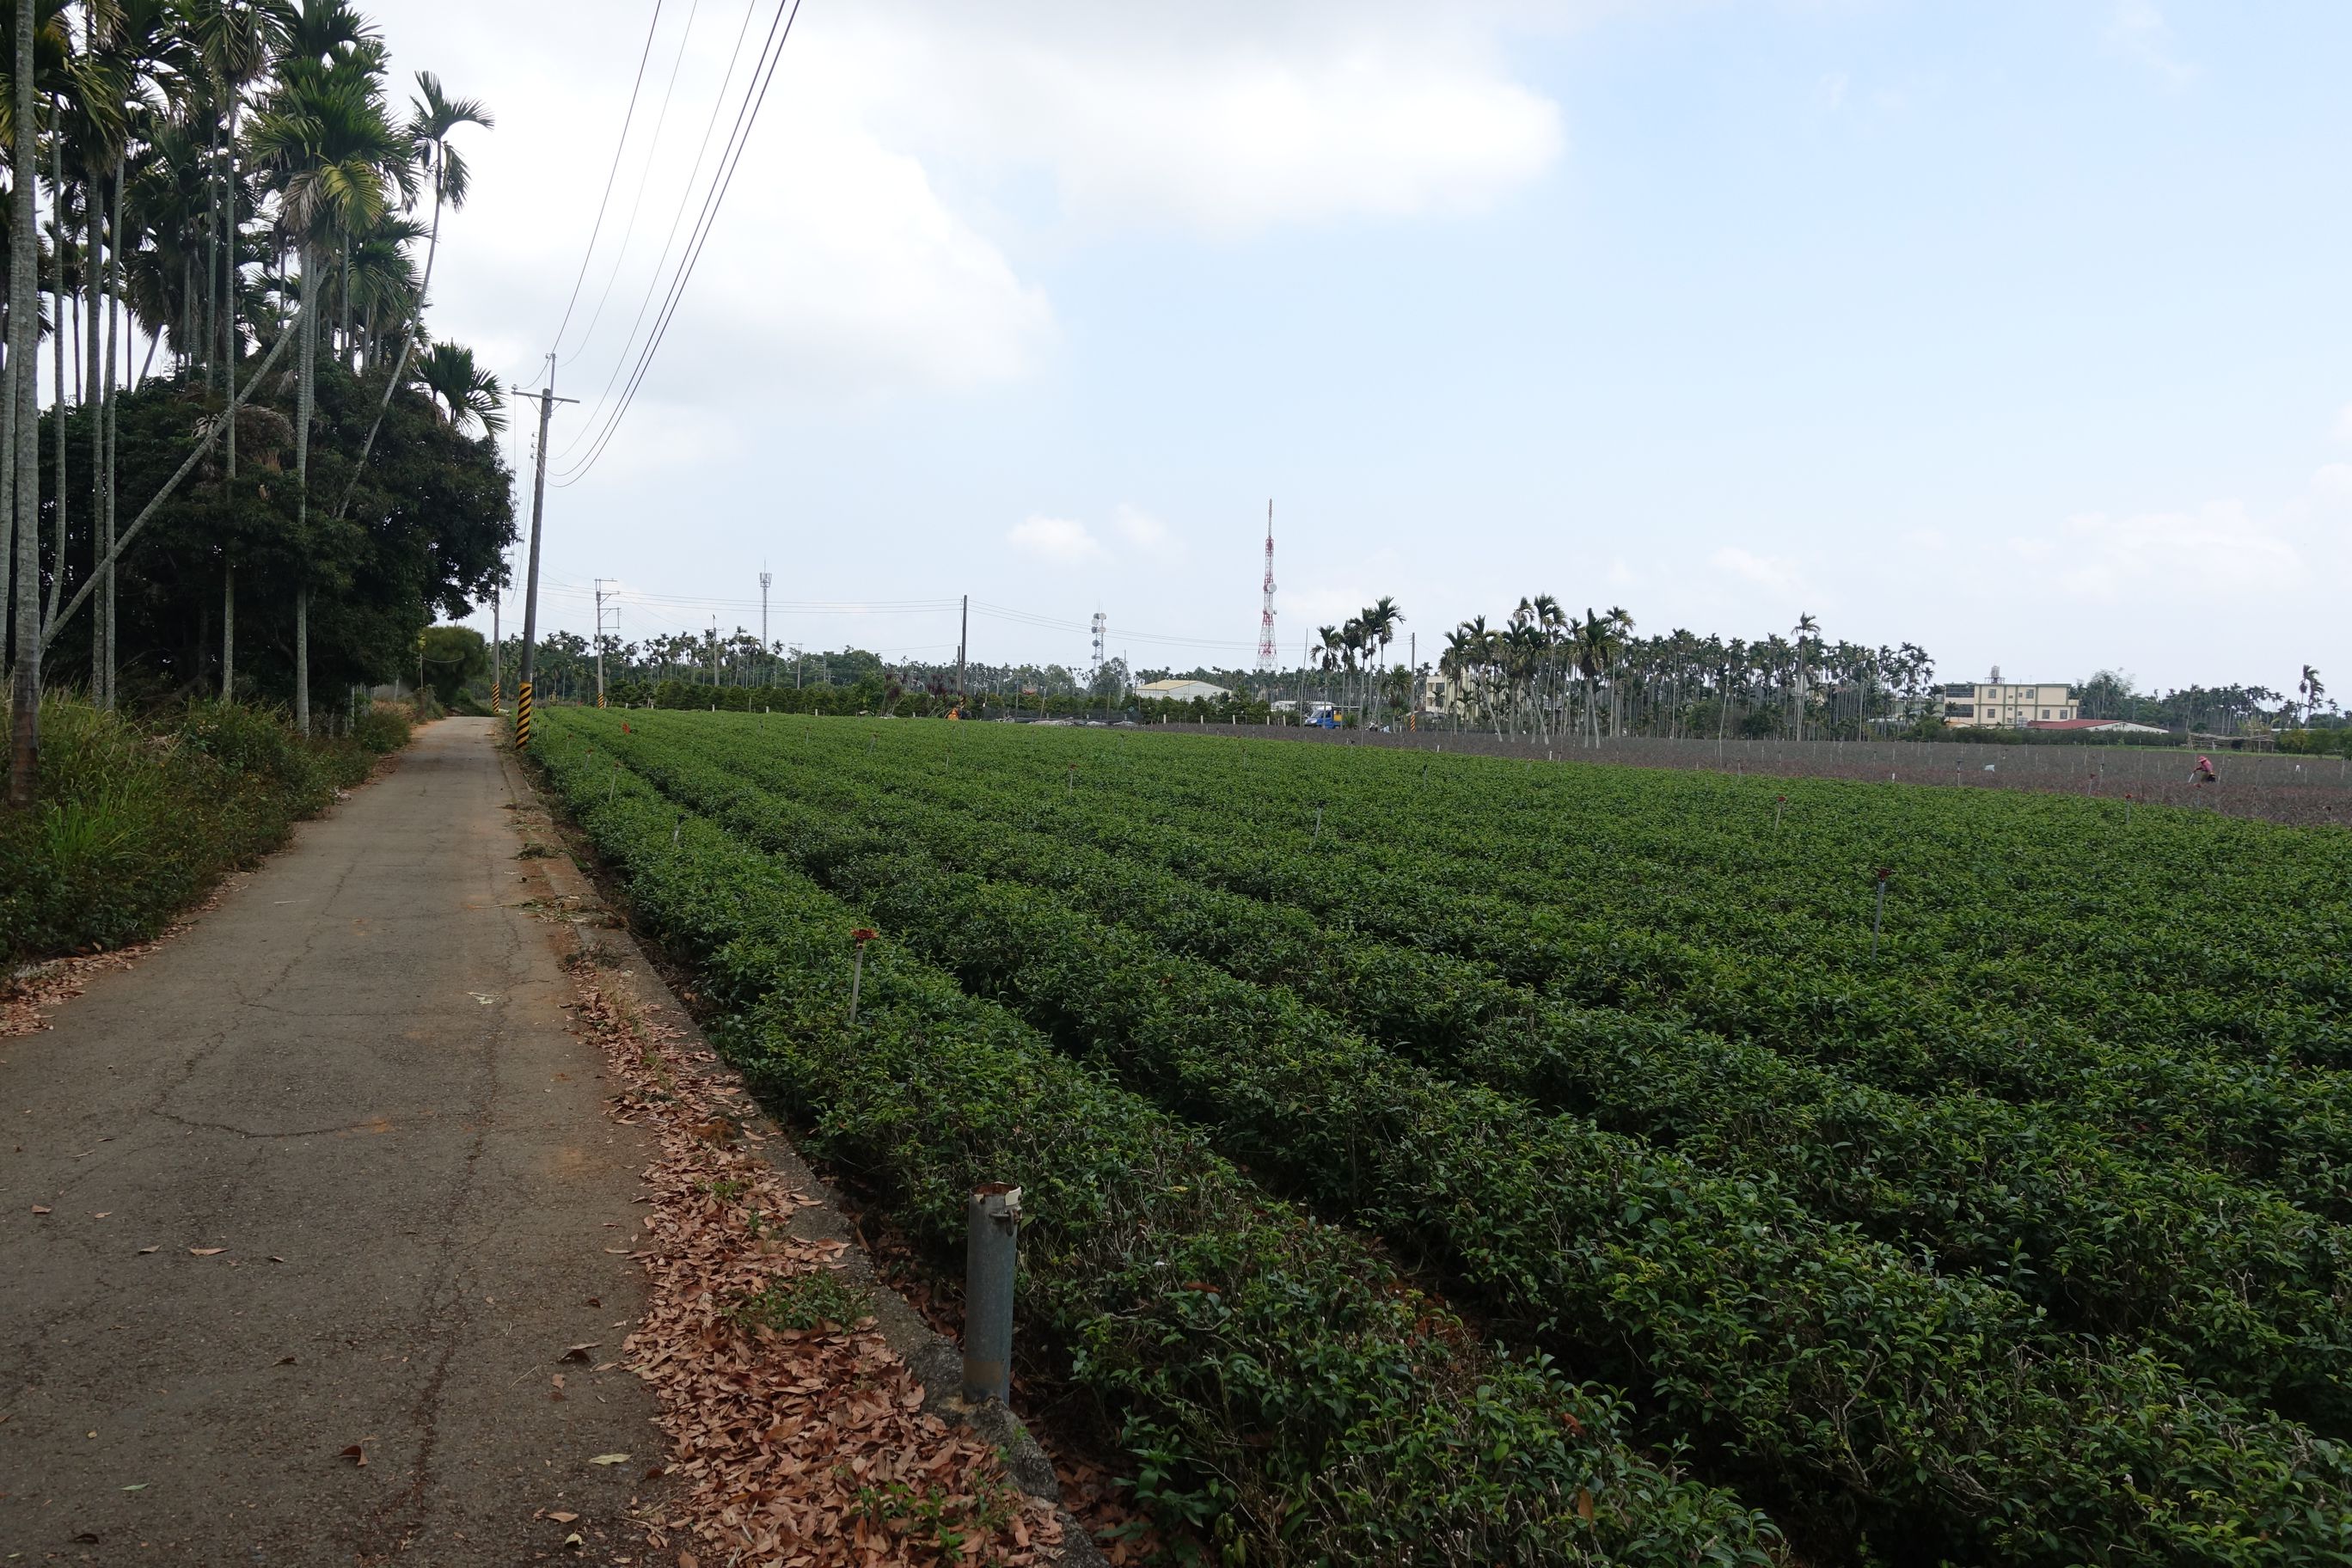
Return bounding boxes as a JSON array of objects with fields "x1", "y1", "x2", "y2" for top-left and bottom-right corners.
[{"x1": 614, "y1": 736, "x2": 2352, "y2": 1434}]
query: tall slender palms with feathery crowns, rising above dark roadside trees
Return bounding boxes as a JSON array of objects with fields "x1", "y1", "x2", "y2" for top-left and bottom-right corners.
[{"x1": 0, "y1": 0, "x2": 496, "y2": 799}]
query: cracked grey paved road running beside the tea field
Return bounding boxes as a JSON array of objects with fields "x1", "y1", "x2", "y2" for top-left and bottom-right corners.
[{"x1": 0, "y1": 720, "x2": 664, "y2": 1568}]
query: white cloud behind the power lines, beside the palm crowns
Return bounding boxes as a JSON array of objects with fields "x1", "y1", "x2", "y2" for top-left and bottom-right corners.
[{"x1": 401, "y1": 0, "x2": 1056, "y2": 434}]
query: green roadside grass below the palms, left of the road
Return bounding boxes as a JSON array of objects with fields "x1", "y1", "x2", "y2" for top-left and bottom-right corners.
[{"x1": 0, "y1": 694, "x2": 409, "y2": 966}]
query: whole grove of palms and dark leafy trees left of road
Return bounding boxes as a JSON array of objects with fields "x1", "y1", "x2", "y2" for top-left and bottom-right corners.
[{"x1": 0, "y1": 0, "x2": 515, "y2": 802}]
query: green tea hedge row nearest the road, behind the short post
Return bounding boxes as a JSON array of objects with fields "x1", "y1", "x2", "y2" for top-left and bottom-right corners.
[{"x1": 541, "y1": 738, "x2": 1780, "y2": 1564}]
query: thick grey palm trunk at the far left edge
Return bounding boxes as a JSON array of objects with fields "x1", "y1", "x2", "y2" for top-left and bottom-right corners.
[{"x1": 7, "y1": 4, "x2": 40, "y2": 809}]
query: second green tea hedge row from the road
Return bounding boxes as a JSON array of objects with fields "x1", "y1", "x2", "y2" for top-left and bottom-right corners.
[{"x1": 541, "y1": 720, "x2": 2352, "y2": 1564}]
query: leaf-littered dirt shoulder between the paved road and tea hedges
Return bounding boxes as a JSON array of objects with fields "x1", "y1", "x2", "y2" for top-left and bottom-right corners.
[{"x1": 504, "y1": 757, "x2": 1106, "y2": 1565}]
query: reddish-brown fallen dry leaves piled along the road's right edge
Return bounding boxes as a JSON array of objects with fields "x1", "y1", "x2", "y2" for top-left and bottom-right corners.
[{"x1": 579, "y1": 973, "x2": 1061, "y2": 1568}]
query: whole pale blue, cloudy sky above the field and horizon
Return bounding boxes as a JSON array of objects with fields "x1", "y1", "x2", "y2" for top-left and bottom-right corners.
[{"x1": 370, "y1": 0, "x2": 2352, "y2": 689}]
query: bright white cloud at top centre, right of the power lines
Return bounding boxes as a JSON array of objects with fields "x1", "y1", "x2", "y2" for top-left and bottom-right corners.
[{"x1": 825, "y1": 0, "x2": 1564, "y2": 235}]
